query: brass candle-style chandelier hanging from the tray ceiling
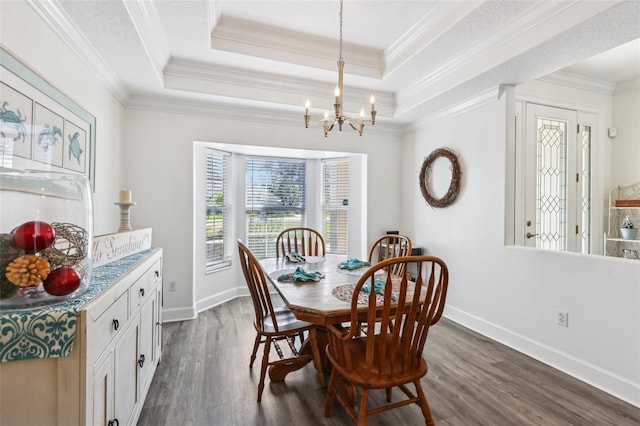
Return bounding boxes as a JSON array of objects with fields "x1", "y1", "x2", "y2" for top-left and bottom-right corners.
[{"x1": 304, "y1": 0, "x2": 376, "y2": 137}]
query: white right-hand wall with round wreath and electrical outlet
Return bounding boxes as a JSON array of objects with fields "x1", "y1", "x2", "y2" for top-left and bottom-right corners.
[{"x1": 403, "y1": 92, "x2": 640, "y2": 406}]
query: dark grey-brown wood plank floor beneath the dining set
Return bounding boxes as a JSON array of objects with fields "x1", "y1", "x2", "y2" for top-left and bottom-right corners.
[{"x1": 138, "y1": 298, "x2": 640, "y2": 426}]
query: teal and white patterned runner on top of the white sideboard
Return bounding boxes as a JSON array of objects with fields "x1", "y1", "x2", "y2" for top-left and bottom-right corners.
[{"x1": 0, "y1": 248, "x2": 155, "y2": 362}]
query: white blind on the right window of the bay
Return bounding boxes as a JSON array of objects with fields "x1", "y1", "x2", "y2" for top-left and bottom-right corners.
[{"x1": 322, "y1": 158, "x2": 349, "y2": 254}]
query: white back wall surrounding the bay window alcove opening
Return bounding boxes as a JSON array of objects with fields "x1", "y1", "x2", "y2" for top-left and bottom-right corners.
[{"x1": 124, "y1": 106, "x2": 402, "y2": 320}]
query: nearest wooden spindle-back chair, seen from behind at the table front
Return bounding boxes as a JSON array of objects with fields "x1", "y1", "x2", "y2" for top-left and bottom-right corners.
[{"x1": 325, "y1": 256, "x2": 449, "y2": 426}]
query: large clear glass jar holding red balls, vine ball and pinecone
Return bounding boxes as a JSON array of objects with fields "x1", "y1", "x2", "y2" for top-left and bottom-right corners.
[{"x1": 0, "y1": 169, "x2": 93, "y2": 309}]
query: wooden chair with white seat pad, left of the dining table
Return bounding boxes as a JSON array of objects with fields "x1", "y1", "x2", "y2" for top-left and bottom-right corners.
[{"x1": 238, "y1": 240, "x2": 324, "y2": 402}]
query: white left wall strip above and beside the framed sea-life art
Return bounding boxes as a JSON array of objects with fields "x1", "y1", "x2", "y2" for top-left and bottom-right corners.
[{"x1": 0, "y1": 0, "x2": 124, "y2": 234}]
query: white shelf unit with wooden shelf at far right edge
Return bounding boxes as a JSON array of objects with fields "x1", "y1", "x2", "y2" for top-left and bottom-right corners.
[{"x1": 604, "y1": 182, "x2": 640, "y2": 259}]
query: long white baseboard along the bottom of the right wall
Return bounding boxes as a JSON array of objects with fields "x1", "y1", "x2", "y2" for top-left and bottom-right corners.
[{"x1": 444, "y1": 306, "x2": 640, "y2": 407}]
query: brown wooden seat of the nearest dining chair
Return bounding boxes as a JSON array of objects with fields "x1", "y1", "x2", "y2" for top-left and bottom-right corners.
[{"x1": 327, "y1": 336, "x2": 428, "y2": 389}]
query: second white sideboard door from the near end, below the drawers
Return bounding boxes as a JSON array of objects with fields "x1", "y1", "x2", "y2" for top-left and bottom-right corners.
[{"x1": 113, "y1": 316, "x2": 140, "y2": 426}]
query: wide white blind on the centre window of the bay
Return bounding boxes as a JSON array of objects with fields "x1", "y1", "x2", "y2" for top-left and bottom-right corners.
[{"x1": 245, "y1": 157, "x2": 306, "y2": 259}]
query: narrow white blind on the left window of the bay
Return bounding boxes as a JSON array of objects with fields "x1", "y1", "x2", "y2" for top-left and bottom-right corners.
[{"x1": 205, "y1": 148, "x2": 231, "y2": 271}]
